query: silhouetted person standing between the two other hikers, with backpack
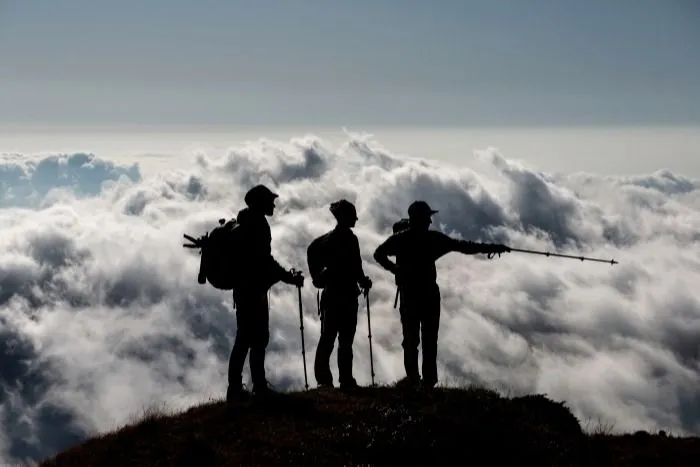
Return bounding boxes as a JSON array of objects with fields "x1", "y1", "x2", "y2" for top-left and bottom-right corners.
[{"x1": 307, "y1": 199, "x2": 372, "y2": 388}]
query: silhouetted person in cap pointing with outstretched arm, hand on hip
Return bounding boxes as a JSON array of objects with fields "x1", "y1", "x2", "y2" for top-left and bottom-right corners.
[{"x1": 374, "y1": 201, "x2": 509, "y2": 387}]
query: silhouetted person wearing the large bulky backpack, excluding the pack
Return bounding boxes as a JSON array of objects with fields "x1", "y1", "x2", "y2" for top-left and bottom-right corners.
[{"x1": 226, "y1": 185, "x2": 304, "y2": 400}]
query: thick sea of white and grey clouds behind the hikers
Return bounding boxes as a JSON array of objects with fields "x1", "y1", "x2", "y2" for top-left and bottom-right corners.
[{"x1": 0, "y1": 135, "x2": 700, "y2": 462}]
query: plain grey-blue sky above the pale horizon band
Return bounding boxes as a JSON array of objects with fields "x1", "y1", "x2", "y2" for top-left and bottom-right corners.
[{"x1": 0, "y1": 0, "x2": 700, "y2": 126}]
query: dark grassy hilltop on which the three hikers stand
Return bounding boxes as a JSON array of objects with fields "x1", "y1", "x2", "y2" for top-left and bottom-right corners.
[{"x1": 42, "y1": 387, "x2": 700, "y2": 466}]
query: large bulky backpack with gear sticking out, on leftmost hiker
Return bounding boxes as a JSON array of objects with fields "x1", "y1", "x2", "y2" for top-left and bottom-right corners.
[{"x1": 183, "y1": 218, "x2": 243, "y2": 290}]
